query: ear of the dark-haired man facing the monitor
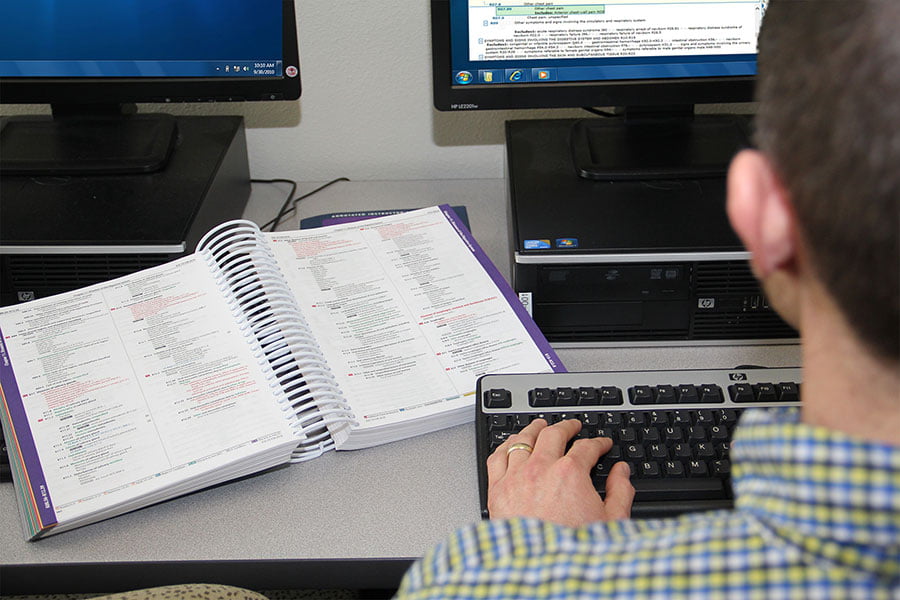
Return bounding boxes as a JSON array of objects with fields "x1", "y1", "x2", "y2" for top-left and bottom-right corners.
[{"x1": 728, "y1": 150, "x2": 797, "y2": 280}]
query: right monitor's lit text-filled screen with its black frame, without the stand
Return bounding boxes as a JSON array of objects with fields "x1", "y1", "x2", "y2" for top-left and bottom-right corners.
[{"x1": 431, "y1": 0, "x2": 767, "y2": 110}]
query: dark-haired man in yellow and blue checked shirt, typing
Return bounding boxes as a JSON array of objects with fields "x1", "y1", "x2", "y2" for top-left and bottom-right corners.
[{"x1": 399, "y1": 0, "x2": 900, "y2": 599}]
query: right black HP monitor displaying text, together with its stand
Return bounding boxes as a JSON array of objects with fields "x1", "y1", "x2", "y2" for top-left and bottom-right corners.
[{"x1": 431, "y1": 0, "x2": 768, "y2": 179}]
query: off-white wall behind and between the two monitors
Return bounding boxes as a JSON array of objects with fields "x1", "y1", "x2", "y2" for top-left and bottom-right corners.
[{"x1": 2, "y1": 0, "x2": 752, "y2": 181}]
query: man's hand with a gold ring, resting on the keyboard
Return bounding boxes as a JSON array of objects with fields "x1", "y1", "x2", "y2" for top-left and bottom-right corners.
[{"x1": 487, "y1": 419, "x2": 634, "y2": 527}]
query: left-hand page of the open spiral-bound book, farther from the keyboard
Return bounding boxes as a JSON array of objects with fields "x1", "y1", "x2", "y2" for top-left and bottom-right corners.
[{"x1": 0, "y1": 256, "x2": 296, "y2": 529}]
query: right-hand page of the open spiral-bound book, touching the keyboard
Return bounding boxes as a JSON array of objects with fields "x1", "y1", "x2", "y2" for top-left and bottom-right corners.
[{"x1": 270, "y1": 207, "x2": 558, "y2": 448}]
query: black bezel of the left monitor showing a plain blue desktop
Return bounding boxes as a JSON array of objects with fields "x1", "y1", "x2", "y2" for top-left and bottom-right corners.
[{"x1": 0, "y1": 0, "x2": 301, "y2": 106}]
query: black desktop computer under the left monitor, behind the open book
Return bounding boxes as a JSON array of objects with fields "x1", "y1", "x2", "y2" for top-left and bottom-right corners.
[{"x1": 0, "y1": 116, "x2": 250, "y2": 306}]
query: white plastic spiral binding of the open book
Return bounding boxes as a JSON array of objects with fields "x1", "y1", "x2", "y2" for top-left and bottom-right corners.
[{"x1": 197, "y1": 221, "x2": 356, "y2": 462}]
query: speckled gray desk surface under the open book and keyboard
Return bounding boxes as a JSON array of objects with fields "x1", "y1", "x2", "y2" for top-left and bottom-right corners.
[{"x1": 0, "y1": 179, "x2": 799, "y2": 594}]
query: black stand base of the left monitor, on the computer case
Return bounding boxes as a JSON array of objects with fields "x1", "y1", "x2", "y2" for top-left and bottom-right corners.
[{"x1": 0, "y1": 105, "x2": 178, "y2": 176}]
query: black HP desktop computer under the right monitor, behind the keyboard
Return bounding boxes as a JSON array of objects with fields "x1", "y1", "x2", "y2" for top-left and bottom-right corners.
[{"x1": 506, "y1": 119, "x2": 797, "y2": 347}]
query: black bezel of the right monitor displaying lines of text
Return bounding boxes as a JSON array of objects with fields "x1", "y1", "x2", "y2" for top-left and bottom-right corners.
[{"x1": 431, "y1": 0, "x2": 755, "y2": 111}]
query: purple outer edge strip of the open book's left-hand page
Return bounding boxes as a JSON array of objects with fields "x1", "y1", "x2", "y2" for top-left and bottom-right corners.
[{"x1": 0, "y1": 331, "x2": 57, "y2": 531}]
